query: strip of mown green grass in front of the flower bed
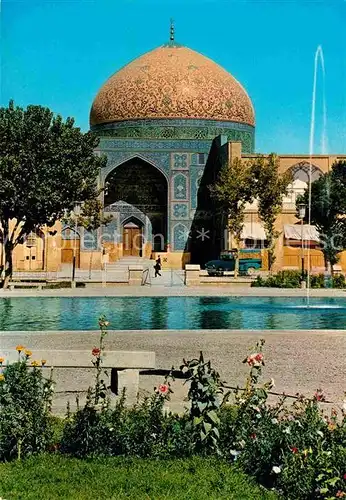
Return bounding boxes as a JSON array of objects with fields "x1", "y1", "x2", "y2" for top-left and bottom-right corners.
[{"x1": 0, "y1": 455, "x2": 277, "y2": 500}]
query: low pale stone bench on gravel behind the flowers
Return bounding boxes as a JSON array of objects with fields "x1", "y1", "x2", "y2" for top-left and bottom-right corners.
[{"x1": 0, "y1": 350, "x2": 156, "y2": 411}]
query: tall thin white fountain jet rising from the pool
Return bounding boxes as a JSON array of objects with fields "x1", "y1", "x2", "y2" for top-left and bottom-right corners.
[{"x1": 306, "y1": 45, "x2": 327, "y2": 306}]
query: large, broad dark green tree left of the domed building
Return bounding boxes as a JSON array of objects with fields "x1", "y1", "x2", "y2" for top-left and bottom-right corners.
[{"x1": 0, "y1": 101, "x2": 106, "y2": 287}]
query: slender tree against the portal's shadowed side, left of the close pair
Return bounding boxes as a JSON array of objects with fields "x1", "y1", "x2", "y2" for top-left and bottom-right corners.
[{"x1": 209, "y1": 158, "x2": 254, "y2": 277}]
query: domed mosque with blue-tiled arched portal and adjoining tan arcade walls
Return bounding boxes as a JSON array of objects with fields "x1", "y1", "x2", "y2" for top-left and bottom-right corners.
[{"x1": 9, "y1": 26, "x2": 346, "y2": 271}]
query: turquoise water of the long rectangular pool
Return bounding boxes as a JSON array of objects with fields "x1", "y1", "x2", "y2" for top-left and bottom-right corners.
[{"x1": 0, "y1": 297, "x2": 346, "y2": 331}]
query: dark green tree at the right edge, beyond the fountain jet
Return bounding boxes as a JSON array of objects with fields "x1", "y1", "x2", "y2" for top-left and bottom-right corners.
[{"x1": 297, "y1": 161, "x2": 346, "y2": 272}]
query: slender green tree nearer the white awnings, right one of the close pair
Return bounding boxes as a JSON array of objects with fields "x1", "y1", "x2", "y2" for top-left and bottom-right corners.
[{"x1": 252, "y1": 153, "x2": 292, "y2": 270}]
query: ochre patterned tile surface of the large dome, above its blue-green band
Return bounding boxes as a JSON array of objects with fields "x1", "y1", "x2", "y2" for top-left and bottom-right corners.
[{"x1": 90, "y1": 46, "x2": 255, "y2": 125}]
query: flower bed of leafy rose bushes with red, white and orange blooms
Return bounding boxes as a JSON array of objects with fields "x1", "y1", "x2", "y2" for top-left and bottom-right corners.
[{"x1": 0, "y1": 318, "x2": 346, "y2": 500}]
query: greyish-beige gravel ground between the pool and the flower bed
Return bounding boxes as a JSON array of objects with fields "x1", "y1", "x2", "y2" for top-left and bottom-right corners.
[{"x1": 0, "y1": 330, "x2": 346, "y2": 411}]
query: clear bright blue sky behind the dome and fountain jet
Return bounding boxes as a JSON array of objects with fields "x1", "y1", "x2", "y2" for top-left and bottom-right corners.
[{"x1": 0, "y1": 0, "x2": 346, "y2": 154}]
